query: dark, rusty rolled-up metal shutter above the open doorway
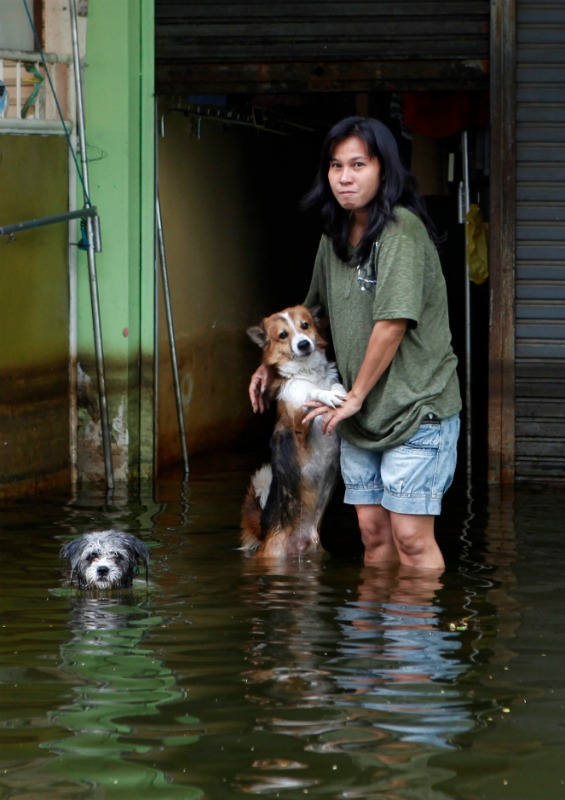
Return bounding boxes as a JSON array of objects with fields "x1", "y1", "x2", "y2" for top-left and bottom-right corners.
[{"x1": 155, "y1": 0, "x2": 490, "y2": 94}]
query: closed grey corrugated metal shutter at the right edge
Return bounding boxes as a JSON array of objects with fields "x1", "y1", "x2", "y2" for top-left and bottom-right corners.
[{"x1": 516, "y1": 0, "x2": 565, "y2": 480}]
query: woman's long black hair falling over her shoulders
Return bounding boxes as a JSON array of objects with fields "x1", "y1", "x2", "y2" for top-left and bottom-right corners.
[{"x1": 301, "y1": 117, "x2": 439, "y2": 261}]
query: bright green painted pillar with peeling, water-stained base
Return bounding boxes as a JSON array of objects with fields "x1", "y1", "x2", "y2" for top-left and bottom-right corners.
[{"x1": 77, "y1": 0, "x2": 154, "y2": 481}]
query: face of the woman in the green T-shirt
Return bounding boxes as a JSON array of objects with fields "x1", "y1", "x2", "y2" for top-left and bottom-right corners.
[{"x1": 328, "y1": 136, "x2": 381, "y2": 212}]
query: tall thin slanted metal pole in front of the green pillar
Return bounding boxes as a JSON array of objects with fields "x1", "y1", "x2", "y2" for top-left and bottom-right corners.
[{"x1": 69, "y1": 0, "x2": 114, "y2": 489}]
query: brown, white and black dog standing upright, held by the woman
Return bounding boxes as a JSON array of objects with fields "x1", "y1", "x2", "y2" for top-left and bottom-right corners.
[{"x1": 241, "y1": 306, "x2": 346, "y2": 558}]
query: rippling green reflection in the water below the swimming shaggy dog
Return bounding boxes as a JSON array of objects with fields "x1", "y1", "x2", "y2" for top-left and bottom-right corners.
[{"x1": 41, "y1": 591, "x2": 201, "y2": 800}]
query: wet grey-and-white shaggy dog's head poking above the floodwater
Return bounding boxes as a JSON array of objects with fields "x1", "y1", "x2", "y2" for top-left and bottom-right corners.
[{"x1": 61, "y1": 530, "x2": 149, "y2": 589}]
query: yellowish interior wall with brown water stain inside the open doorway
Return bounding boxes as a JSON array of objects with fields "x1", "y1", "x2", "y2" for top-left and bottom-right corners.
[{"x1": 153, "y1": 111, "x2": 269, "y2": 465}]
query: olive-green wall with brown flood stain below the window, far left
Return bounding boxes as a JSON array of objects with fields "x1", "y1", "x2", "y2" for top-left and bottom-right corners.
[{"x1": 0, "y1": 134, "x2": 71, "y2": 497}]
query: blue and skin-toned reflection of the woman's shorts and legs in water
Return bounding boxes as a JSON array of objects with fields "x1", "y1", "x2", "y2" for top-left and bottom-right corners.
[{"x1": 335, "y1": 567, "x2": 469, "y2": 728}]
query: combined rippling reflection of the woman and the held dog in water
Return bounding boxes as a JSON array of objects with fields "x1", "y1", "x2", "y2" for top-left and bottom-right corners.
[{"x1": 240, "y1": 560, "x2": 473, "y2": 797}]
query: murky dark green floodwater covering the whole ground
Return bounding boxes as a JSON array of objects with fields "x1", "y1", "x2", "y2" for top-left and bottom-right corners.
[{"x1": 0, "y1": 453, "x2": 565, "y2": 800}]
